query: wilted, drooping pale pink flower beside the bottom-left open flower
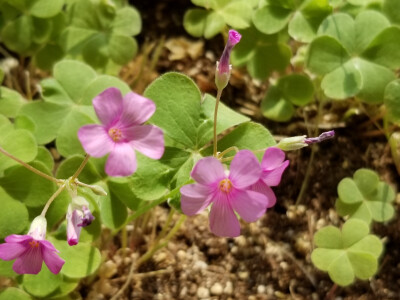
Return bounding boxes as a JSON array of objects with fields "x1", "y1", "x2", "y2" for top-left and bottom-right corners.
[{"x1": 66, "y1": 196, "x2": 94, "y2": 246}]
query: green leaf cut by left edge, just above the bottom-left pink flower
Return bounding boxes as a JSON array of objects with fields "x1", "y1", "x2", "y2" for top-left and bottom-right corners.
[{"x1": 0, "y1": 188, "x2": 29, "y2": 239}]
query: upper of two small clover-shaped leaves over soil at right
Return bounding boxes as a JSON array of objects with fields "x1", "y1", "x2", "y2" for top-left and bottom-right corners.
[{"x1": 336, "y1": 169, "x2": 395, "y2": 224}]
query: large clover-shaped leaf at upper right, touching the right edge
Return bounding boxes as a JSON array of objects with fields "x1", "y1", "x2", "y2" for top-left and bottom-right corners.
[{"x1": 307, "y1": 11, "x2": 400, "y2": 103}]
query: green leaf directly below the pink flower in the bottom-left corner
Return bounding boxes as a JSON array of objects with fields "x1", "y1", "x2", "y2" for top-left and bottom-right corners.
[{"x1": 22, "y1": 264, "x2": 62, "y2": 298}]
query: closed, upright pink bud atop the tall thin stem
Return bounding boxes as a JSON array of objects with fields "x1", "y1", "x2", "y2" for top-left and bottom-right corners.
[{"x1": 215, "y1": 30, "x2": 242, "y2": 90}]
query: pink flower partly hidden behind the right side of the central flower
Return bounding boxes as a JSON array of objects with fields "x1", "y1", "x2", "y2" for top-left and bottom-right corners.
[{"x1": 251, "y1": 147, "x2": 289, "y2": 208}]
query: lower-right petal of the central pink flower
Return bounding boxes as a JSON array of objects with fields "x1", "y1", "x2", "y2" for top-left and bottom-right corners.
[{"x1": 231, "y1": 190, "x2": 268, "y2": 222}]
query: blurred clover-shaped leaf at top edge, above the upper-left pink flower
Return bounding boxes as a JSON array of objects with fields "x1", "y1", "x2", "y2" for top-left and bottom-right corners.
[{"x1": 61, "y1": 0, "x2": 142, "y2": 69}]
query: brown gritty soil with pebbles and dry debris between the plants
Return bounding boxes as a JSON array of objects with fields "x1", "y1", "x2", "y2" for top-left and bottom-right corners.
[{"x1": 5, "y1": 0, "x2": 400, "y2": 300}]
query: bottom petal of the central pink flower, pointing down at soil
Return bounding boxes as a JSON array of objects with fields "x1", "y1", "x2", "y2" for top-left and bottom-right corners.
[{"x1": 210, "y1": 192, "x2": 240, "y2": 237}]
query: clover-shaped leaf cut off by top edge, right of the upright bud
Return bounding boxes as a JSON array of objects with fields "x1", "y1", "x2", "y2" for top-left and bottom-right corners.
[{"x1": 253, "y1": 0, "x2": 332, "y2": 42}]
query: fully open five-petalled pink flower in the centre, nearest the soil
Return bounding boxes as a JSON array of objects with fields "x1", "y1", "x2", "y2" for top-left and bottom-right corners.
[{"x1": 180, "y1": 150, "x2": 268, "y2": 237}]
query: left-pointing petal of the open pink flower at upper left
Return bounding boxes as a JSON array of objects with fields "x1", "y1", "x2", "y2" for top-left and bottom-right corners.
[{"x1": 78, "y1": 124, "x2": 114, "y2": 157}]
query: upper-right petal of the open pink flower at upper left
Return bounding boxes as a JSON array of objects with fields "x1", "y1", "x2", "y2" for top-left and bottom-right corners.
[{"x1": 120, "y1": 92, "x2": 156, "y2": 127}]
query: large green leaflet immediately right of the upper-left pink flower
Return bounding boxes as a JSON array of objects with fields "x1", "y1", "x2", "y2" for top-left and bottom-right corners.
[{"x1": 144, "y1": 73, "x2": 201, "y2": 149}]
